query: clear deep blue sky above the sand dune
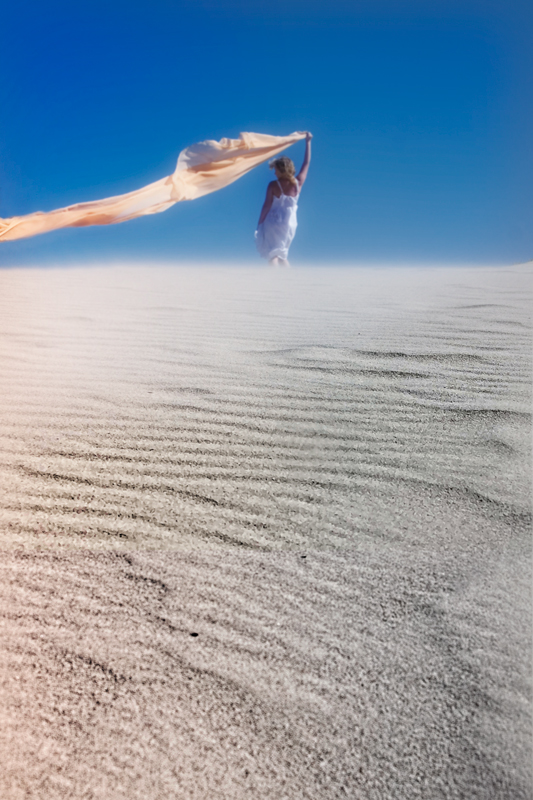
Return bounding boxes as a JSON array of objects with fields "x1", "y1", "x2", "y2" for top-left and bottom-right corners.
[{"x1": 0, "y1": 0, "x2": 533, "y2": 266}]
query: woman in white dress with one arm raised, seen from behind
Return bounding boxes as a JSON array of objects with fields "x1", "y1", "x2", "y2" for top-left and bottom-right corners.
[{"x1": 255, "y1": 131, "x2": 313, "y2": 267}]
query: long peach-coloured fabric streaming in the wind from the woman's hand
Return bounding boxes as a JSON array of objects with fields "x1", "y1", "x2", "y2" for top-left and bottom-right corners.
[{"x1": 0, "y1": 133, "x2": 305, "y2": 241}]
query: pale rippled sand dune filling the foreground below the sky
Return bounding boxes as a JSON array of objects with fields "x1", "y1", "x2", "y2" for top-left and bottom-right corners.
[{"x1": 0, "y1": 266, "x2": 532, "y2": 800}]
